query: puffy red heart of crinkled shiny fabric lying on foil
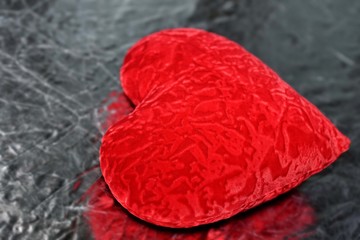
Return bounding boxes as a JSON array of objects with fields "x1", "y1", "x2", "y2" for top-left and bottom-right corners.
[{"x1": 100, "y1": 29, "x2": 350, "y2": 227}]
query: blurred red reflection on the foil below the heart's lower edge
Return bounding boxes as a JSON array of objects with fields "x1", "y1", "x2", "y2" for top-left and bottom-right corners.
[{"x1": 84, "y1": 178, "x2": 315, "y2": 240}]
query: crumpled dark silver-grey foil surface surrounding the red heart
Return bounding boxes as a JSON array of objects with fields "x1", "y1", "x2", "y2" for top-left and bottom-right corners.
[{"x1": 0, "y1": 0, "x2": 360, "y2": 239}]
